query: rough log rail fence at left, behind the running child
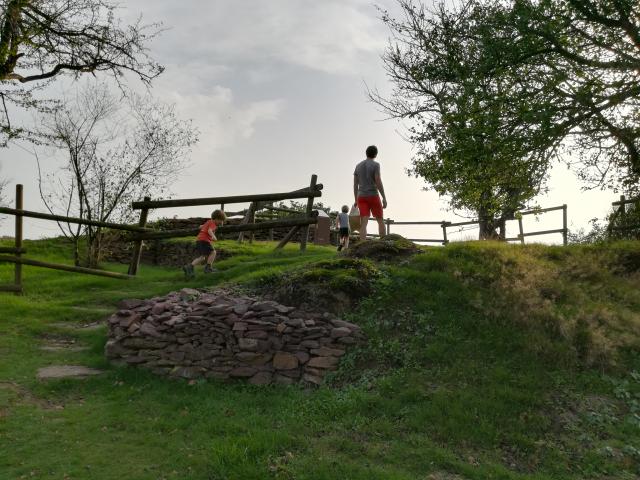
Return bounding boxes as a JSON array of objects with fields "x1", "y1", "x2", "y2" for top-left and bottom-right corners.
[{"x1": 0, "y1": 175, "x2": 322, "y2": 294}]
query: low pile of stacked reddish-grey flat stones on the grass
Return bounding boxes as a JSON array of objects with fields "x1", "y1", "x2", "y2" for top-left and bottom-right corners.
[{"x1": 105, "y1": 288, "x2": 364, "y2": 385}]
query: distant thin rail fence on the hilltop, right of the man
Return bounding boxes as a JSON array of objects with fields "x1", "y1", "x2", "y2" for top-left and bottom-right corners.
[{"x1": 368, "y1": 205, "x2": 569, "y2": 245}]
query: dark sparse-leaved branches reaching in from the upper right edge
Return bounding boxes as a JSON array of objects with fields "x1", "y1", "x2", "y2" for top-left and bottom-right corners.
[{"x1": 512, "y1": 0, "x2": 640, "y2": 193}]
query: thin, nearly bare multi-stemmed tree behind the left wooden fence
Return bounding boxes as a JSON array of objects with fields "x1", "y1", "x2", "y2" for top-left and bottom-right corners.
[{"x1": 38, "y1": 84, "x2": 197, "y2": 267}]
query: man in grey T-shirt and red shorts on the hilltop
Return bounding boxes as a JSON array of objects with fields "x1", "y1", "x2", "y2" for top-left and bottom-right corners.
[{"x1": 353, "y1": 145, "x2": 387, "y2": 240}]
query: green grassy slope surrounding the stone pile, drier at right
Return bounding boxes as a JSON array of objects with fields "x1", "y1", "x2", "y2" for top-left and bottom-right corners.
[{"x1": 0, "y1": 241, "x2": 640, "y2": 479}]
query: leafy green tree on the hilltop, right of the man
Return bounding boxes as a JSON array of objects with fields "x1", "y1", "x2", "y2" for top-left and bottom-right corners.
[{"x1": 369, "y1": 0, "x2": 556, "y2": 238}]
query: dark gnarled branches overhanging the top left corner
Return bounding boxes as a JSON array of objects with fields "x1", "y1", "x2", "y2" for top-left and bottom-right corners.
[{"x1": 0, "y1": 0, "x2": 163, "y2": 145}]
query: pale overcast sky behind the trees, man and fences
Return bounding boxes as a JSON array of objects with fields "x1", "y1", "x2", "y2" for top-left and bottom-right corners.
[{"x1": 0, "y1": 0, "x2": 617, "y2": 243}]
